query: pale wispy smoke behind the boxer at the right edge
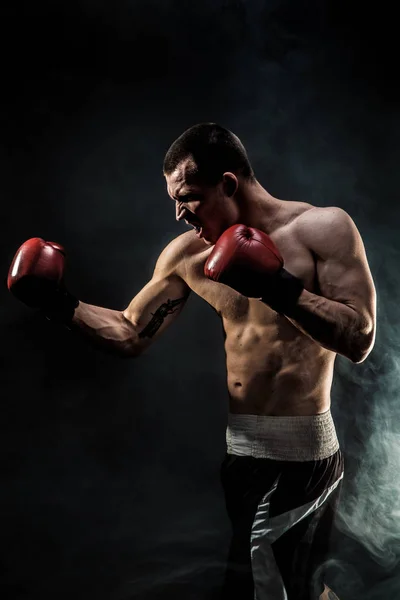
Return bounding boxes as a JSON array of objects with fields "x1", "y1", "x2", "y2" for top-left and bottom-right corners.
[{"x1": 336, "y1": 245, "x2": 400, "y2": 576}]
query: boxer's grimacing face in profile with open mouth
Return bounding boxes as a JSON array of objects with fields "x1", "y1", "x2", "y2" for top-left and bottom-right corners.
[{"x1": 165, "y1": 160, "x2": 238, "y2": 245}]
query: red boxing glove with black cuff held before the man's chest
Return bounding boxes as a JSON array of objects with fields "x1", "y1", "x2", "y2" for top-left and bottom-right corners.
[{"x1": 204, "y1": 225, "x2": 303, "y2": 312}]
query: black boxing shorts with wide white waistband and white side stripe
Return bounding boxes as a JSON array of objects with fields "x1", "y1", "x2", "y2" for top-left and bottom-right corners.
[{"x1": 221, "y1": 411, "x2": 343, "y2": 600}]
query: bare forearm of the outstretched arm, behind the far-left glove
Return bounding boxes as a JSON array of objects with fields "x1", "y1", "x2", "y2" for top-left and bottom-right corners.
[{"x1": 71, "y1": 302, "x2": 140, "y2": 357}]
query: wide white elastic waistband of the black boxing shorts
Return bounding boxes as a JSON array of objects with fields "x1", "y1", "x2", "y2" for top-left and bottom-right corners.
[{"x1": 226, "y1": 410, "x2": 339, "y2": 461}]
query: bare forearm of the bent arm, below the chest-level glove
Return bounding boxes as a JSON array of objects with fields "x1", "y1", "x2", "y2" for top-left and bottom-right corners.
[{"x1": 286, "y1": 290, "x2": 373, "y2": 362}]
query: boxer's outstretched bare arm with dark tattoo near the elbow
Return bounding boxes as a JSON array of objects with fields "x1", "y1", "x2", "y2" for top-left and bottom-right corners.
[{"x1": 72, "y1": 240, "x2": 190, "y2": 357}]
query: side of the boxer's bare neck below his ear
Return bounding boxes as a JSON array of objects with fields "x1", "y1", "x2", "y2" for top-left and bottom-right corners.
[{"x1": 238, "y1": 180, "x2": 284, "y2": 233}]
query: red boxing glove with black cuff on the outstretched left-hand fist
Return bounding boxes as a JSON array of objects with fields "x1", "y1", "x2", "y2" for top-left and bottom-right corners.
[{"x1": 7, "y1": 238, "x2": 79, "y2": 322}]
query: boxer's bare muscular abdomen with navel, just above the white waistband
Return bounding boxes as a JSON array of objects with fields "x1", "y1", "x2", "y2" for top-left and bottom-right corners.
[{"x1": 224, "y1": 309, "x2": 335, "y2": 416}]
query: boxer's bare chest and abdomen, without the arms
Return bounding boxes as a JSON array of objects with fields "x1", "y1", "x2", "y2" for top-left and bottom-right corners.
[{"x1": 182, "y1": 202, "x2": 335, "y2": 415}]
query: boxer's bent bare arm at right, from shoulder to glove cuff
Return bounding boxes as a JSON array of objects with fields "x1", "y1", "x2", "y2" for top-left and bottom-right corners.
[{"x1": 286, "y1": 208, "x2": 376, "y2": 363}]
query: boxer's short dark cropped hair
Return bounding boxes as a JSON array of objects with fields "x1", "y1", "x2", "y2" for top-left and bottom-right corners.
[{"x1": 163, "y1": 123, "x2": 254, "y2": 185}]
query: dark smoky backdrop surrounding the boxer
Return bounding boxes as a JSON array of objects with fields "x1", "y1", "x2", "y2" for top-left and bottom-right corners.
[{"x1": 0, "y1": 0, "x2": 400, "y2": 600}]
